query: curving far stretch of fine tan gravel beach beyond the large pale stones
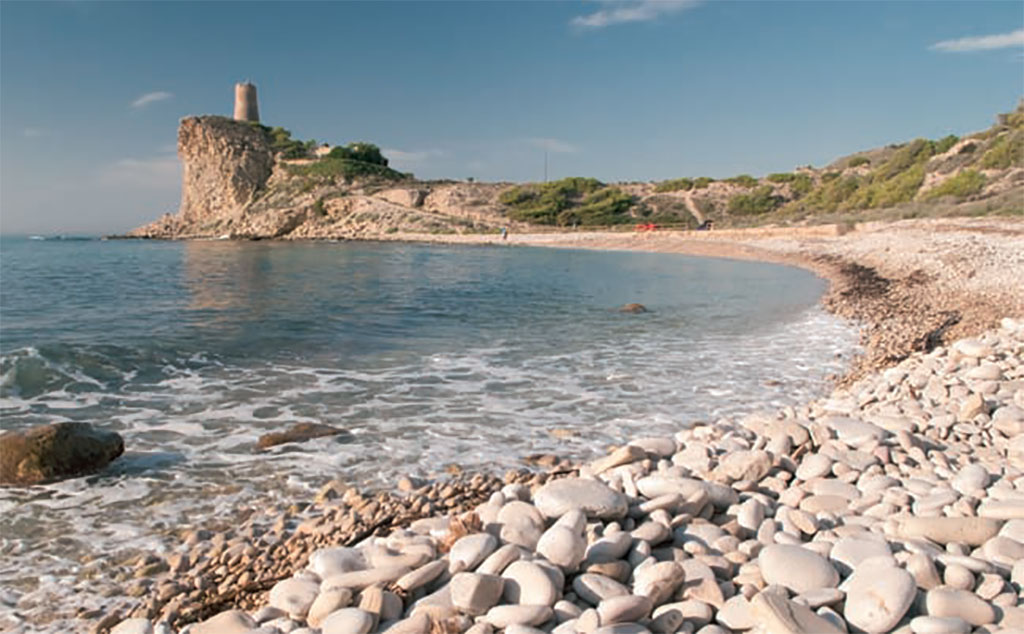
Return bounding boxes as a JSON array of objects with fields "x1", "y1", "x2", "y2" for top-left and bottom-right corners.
[{"x1": 383, "y1": 218, "x2": 1024, "y2": 385}]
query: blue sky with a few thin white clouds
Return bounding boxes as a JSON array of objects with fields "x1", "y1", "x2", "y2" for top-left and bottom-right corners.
[{"x1": 0, "y1": 0, "x2": 1024, "y2": 234}]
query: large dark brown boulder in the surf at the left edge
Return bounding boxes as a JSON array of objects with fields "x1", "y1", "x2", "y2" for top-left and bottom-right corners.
[{"x1": 0, "y1": 422, "x2": 125, "y2": 487}]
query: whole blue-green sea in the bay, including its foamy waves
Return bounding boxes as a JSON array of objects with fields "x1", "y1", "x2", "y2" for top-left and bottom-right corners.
[{"x1": 0, "y1": 237, "x2": 857, "y2": 631}]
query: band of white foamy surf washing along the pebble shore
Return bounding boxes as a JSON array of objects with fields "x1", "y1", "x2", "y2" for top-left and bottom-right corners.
[{"x1": 0, "y1": 307, "x2": 857, "y2": 626}]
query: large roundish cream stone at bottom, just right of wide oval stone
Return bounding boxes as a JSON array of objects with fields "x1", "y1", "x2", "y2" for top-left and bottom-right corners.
[{"x1": 844, "y1": 565, "x2": 918, "y2": 632}]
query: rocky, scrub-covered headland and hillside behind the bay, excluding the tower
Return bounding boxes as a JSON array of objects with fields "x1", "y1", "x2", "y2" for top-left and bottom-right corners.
[{"x1": 130, "y1": 102, "x2": 1024, "y2": 239}]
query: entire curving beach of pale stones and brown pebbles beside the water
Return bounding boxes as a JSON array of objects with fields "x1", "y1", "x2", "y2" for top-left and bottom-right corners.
[{"x1": 24, "y1": 221, "x2": 1024, "y2": 634}]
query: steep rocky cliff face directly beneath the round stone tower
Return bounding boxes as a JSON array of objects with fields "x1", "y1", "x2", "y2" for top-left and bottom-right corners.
[{"x1": 178, "y1": 117, "x2": 273, "y2": 225}]
